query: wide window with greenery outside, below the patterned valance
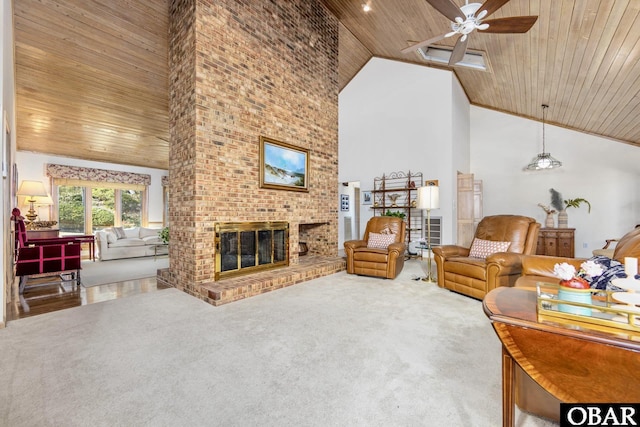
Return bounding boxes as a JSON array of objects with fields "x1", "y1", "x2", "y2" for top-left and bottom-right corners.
[{"x1": 57, "y1": 183, "x2": 146, "y2": 236}]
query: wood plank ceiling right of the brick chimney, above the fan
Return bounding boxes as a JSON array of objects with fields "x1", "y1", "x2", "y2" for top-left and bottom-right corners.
[{"x1": 323, "y1": 0, "x2": 640, "y2": 146}]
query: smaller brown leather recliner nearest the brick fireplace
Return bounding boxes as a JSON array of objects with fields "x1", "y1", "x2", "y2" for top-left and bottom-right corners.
[{"x1": 344, "y1": 216, "x2": 406, "y2": 279}]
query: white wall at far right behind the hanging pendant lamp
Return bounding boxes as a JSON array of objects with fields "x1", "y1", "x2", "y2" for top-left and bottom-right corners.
[{"x1": 471, "y1": 106, "x2": 640, "y2": 257}]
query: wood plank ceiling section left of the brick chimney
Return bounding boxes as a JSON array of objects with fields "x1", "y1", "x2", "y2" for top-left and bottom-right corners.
[{"x1": 14, "y1": 0, "x2": 169, "y2": 169}]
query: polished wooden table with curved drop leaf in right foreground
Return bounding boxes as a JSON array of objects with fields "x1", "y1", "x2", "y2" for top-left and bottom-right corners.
[{"x1": 483, "y1": 287, "x2": 640, "y2": 426}]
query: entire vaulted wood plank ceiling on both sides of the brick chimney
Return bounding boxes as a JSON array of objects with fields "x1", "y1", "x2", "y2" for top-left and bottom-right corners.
[{"x1": 14, "y1": 0, "x2": 640, "y2": 172}]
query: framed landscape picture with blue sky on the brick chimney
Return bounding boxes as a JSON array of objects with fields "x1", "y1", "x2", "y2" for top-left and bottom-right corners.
[{"x1": 260, "y1": 136, "x2": 309, "y2": 191}]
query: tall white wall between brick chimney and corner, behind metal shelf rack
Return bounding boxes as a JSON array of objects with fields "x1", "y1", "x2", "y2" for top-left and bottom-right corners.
[{"x1": 338, "y1": 58, "x2": 469, "y2": 247}]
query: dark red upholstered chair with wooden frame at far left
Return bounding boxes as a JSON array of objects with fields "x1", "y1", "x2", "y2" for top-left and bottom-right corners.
[{"x1": 13, "y1": 209, "x2": 82, "y2": 294}]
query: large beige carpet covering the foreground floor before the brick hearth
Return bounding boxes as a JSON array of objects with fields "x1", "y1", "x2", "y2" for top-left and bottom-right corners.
[{"x1": 0, "y1": 260, "x2": 553, "y2": 427}]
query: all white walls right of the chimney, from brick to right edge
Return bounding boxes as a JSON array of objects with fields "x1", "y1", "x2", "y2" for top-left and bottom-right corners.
[{"x1": 339, "y1": 58, "x2": 640, "y2": 257}]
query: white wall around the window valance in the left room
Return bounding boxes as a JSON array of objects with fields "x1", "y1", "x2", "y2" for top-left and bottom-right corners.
[{"x1": 16, "y1": 151, "x2": 168, "y2": 223}]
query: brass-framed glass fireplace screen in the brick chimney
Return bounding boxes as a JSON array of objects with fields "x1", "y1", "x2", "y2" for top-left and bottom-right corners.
[{"x1": 215, "y1": 222, "x2": 289, "y2": 280}]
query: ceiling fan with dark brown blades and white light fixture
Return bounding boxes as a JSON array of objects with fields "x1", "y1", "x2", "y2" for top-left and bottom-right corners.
[{"x1": 401, "y1": 0, "x2": 538, "y2": 66}]
